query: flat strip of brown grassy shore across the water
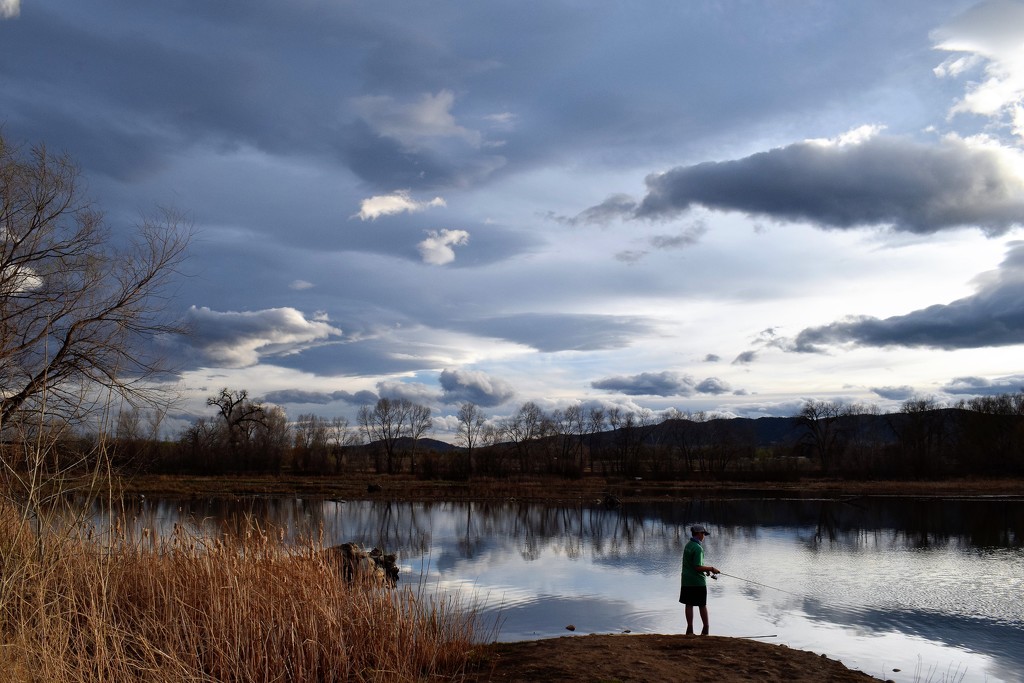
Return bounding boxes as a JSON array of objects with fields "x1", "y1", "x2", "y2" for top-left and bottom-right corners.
[{"x1": 108, "y1": 473, "x2": 1024, "y2": 505}]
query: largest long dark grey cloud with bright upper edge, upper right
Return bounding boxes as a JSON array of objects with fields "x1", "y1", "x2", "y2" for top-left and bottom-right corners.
[{"x1": 577, "y1": 135, "x2": 1024, "y2": 234}]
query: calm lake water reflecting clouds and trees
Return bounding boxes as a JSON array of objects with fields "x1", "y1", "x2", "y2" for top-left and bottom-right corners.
[{"x1": 99, "y1": 491, "x2": 1024, "y2": 682}]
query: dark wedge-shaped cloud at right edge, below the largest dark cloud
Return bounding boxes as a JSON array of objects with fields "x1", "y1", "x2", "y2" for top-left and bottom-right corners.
[{"x1": 793, "y1": 242, "x2": 1024, "y2": 351}]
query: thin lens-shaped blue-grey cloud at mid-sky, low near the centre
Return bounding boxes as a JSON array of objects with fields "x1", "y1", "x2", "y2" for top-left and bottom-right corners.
[{"x1": 460, "y1": 313, "x2": 652, "y2": 352}]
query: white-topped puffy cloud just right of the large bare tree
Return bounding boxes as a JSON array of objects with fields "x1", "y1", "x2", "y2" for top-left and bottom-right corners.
[{"x1": 185, "y1": 306, "x2": 341, "y2": 368}]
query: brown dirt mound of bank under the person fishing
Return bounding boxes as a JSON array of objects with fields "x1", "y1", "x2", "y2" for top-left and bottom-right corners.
[{"x1": 466, "y1": 635, "x2": 882, "y2": 683}]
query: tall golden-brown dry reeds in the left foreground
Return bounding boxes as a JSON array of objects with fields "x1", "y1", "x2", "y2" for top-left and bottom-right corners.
[{"x1": 0, "y1": 507, "x2": 477, "y2": 683}]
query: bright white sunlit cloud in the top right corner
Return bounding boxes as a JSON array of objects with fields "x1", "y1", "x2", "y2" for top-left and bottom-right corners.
[{"x1": 932, "y1": 0, "x2": 1024, "y2": 136}]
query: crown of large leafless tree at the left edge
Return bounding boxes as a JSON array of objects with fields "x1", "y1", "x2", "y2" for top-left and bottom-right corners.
[{"x1": 0, "y1": 137, "x2": 189, "y2": 427}]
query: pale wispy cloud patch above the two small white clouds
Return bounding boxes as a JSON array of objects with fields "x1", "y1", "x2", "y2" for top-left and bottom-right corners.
[{"x1": 351, "y1": 90, "x2": 481, "y2": 150}]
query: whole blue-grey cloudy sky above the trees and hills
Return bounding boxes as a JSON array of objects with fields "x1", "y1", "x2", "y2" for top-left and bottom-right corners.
[{"x1": 0, "y1": 0, "x2": 1024, "y2": 440}]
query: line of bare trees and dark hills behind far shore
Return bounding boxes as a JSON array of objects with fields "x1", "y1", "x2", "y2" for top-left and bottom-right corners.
[{"x1": 96, "y1": 388, "x2": 1024, "y2": 479}]
